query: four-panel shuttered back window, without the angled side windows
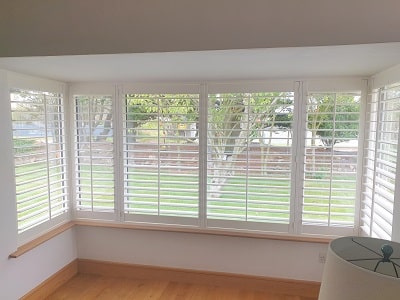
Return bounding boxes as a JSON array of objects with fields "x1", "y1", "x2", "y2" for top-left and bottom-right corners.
[{"x1": 73, "y1": 82, "x2": 362, "y2": 235}]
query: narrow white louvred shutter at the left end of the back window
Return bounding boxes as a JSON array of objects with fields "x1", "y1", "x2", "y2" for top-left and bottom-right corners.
[{"x1": 74, "y1": 95, "x2": 115, "y2": 216}]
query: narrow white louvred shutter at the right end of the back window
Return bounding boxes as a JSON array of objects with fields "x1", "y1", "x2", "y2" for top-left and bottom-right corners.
[{"x1": 302, "y1": 93, "x2": 360, "y2": 234}]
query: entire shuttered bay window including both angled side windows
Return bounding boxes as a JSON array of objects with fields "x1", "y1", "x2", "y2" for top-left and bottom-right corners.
[{"x1": 11, "y1": 76, "x2": 400, "y2": 243}]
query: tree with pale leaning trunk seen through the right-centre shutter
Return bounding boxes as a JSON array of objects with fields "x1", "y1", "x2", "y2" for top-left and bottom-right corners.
[{"x1": 208, "y1": 93, "x2": 293, "y2": 198}]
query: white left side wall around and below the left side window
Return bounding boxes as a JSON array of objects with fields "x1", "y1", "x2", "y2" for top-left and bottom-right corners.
[{"x1": 0, "y1": 70, "x2": 77, "y2": 300}]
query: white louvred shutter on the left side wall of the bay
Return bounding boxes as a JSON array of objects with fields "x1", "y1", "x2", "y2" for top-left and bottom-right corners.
[{"x1": 10, "y1": 89, "x2": 68, "y2": 238}]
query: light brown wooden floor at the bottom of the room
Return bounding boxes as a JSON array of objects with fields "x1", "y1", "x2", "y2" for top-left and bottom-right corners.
[{"x1": 47, "y1": 274, "x2": 317, "y2": 300}]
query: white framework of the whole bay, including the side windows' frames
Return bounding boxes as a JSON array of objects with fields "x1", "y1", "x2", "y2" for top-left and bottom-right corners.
[{"x1": 4, "y1": 67, "x2": 400, "y2": 244}]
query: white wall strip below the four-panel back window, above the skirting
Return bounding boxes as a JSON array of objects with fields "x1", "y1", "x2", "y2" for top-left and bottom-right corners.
[{"x1": 76, "y1": 226, "x2": 328, "y2": 281}]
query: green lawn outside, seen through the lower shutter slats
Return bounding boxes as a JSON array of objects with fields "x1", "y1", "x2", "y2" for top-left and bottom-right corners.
[{"x1": 16, "y1": 157, "x2": 355, "y2": 227}]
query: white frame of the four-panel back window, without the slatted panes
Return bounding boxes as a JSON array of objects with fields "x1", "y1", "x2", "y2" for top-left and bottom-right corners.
[{"x1": 70, "y1": 78, "x2": 366, "y2": 237}]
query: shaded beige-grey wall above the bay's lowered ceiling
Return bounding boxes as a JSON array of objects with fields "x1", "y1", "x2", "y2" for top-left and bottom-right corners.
[{"x1": 0, "y1": 0, "x2": 400, "y2": 56}]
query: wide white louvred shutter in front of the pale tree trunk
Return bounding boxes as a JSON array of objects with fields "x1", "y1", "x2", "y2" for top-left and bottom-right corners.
[{"x1": 207, "y1": 91, "x2": 294, "y2": 232}]
